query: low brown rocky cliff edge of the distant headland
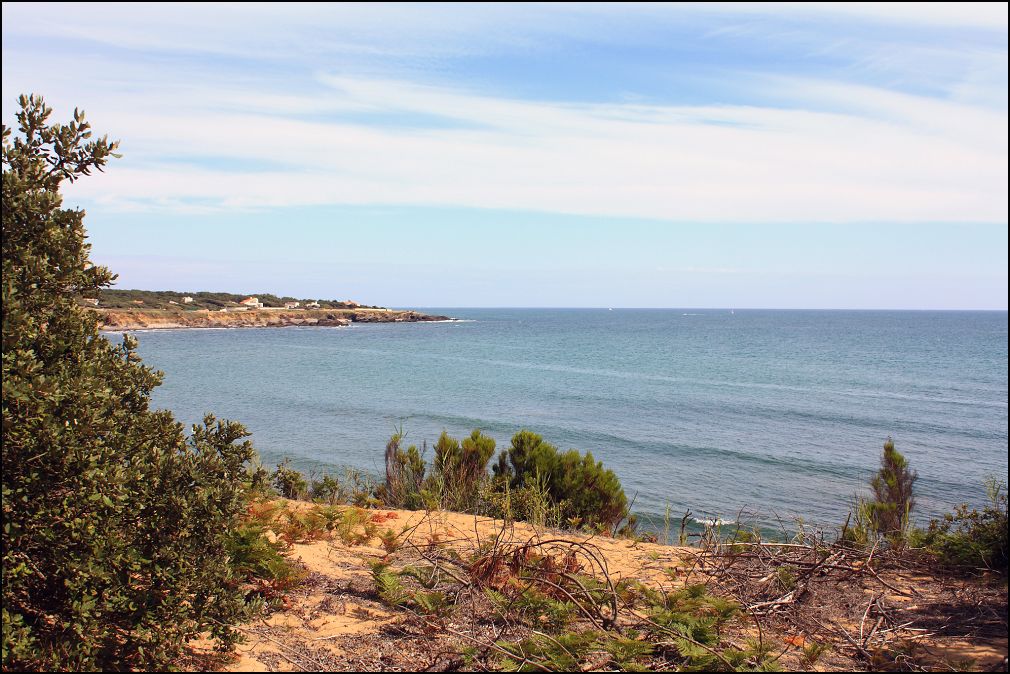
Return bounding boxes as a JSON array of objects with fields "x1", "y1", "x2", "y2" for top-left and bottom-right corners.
[{"x1": 92, "y1": 309, "x2": 452, "y2": 331}]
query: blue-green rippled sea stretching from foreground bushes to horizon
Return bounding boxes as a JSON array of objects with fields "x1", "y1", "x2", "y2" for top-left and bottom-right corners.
[{"x1": 116, "y1": 308, "x2": 1007, "y2": 527}]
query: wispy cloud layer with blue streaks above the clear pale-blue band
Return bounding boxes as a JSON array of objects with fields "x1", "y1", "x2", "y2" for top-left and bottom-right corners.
[{"x1": 3, "y1": 3, "x2": 1007, "y2": 222}]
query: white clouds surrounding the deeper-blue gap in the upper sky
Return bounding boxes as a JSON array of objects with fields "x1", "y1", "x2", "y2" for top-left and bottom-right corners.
[{"x1": 3, "y1": 3, "x2": 1008, "y2": 222}]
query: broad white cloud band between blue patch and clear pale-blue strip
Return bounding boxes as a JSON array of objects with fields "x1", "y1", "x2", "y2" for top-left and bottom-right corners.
[{"x1": 39, "y1": 72, "x2": 1007, "y2": 222}]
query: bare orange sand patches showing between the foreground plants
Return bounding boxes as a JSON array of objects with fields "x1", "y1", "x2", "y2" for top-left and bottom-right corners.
[{"x1": 184, "y1": 509, "x2": 1007, "y2": 672}]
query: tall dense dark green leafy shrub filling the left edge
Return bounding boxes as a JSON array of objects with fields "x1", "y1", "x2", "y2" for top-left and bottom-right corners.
[{"x1": 2, "y1": 96, "x2": 254, "y2": 670}]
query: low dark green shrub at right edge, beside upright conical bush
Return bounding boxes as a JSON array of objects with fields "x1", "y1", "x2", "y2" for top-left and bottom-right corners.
[{"x1": 912, "y1": 477, "x2": 1007, "y2": 576}]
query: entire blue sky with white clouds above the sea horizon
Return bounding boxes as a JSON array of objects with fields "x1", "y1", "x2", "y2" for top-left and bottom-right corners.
[{"x1": 2, "y1": 3, "x2": 1008, "y2": 310}]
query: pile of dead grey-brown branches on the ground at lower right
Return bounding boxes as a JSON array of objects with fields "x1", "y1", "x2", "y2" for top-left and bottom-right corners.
[{"x1": 688, "y1": 535, "x2": 1007, "y2": 671}]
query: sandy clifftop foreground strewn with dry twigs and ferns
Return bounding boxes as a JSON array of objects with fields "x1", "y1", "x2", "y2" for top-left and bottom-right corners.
[{"x1": 182, "y1": 502, "x2": 1007, "y2": 671}]
